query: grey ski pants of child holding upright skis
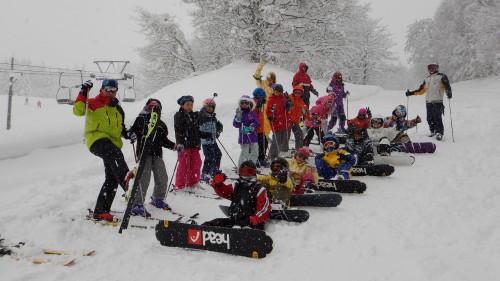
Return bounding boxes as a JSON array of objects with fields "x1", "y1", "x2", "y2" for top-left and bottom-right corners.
[{"x1": 134, "y1": 155, "x2": 168, "y2": 204}]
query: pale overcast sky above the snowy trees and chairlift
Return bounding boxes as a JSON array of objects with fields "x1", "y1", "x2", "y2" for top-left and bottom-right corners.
[{"x1": 0, "y1": 0, "x2": 440, "y2": 69}]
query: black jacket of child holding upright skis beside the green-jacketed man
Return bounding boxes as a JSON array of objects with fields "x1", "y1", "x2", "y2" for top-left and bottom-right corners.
[{"x1": 130, "y1": 114, "x2": 175, "y2": 157}]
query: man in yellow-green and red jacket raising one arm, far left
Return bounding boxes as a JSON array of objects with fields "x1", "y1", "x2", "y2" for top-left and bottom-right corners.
[{"x1": 73, "y1": 79, "x2": 136, "y2": 221}]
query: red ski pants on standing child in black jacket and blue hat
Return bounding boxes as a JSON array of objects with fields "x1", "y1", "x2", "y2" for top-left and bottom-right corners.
[{"x1": 175, "y1": 147, "x2": 201, "y2": 189}]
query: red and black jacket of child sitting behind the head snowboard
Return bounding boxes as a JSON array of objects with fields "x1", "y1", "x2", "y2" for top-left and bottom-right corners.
[{"x1": 213, "y1": 179, "x2": 271, "y2": 224}]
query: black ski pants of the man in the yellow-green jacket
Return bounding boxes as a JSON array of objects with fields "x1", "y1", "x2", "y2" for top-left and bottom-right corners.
[{"x1": 90, "y1": 139, "x2": 129, "y2": 214}]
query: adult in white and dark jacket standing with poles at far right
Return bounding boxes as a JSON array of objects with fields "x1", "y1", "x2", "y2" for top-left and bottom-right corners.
[{"x1": 406, "y1": 63, "x2": 452, "y2": 141}]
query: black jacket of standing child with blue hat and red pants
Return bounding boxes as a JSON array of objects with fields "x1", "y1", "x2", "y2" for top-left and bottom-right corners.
[{"x1": 174, "y1": 108, "x2": 205, "y2": 149}]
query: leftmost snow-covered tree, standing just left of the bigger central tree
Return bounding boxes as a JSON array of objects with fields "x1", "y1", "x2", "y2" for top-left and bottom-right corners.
[{"x1": 136, "y1": 9, "x2": 197, "y2": 91}]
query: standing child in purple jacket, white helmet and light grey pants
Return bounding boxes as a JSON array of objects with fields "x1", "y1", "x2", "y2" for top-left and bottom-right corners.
[{"x1": 233, "y1": 95, "x2": 259, "y2": 167}]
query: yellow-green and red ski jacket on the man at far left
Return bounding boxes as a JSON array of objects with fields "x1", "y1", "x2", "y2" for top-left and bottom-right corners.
[{"x1": 73, "y1": 93, "x2": 127, "y2": 149}]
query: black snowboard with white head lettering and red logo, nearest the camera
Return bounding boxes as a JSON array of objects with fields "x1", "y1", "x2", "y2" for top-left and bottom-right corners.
[{"x1": 155, "y1": 220, "x2": 273, "y2": 259}]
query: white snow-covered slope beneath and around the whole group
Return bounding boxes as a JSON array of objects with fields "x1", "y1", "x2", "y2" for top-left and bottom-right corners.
[{"x1": 0, "y1": 62, "x2": 500, "y2": 281}]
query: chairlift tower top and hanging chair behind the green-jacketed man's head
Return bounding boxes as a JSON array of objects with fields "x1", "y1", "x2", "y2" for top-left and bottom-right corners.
[{"x1": 90, "y1": 60, "x2": 136, "y2": 102}]
